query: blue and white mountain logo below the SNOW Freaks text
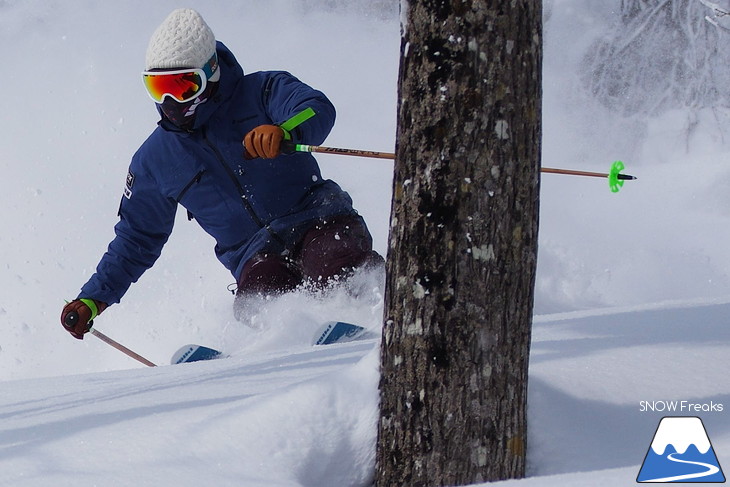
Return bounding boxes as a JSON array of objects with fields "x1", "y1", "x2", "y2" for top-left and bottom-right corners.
[{"x1": 636, "y1": 416, "x2": 725, "y2": 483}]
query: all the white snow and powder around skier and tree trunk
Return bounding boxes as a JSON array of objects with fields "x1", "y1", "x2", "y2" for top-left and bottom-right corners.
[{"x1": 0, "y1": 0, "x2": 730, "y2": 487}]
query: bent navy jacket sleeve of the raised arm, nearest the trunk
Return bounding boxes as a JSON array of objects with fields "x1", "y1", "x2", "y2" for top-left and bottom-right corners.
[{"x1": 263, "y1": 71, "x2": 335, "y2": 145}]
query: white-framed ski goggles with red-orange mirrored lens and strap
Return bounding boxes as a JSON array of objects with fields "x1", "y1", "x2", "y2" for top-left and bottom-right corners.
[{"x1": 142, "y1": 53, "x2": 218, "y2": 103}]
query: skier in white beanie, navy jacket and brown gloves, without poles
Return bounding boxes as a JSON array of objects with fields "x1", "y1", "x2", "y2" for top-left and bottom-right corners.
[{"x1": 61, "y1": 9, "x2": 383, "y2": 339}]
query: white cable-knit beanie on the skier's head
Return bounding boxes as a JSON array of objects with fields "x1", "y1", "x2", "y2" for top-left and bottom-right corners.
[{"x1": 145, "y1": 8, "x2": 215, "y2": 70}]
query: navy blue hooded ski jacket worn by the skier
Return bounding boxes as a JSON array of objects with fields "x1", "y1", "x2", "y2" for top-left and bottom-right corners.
[{"x1": 79, "y1": 42, "x2": 357, "y2": 304}]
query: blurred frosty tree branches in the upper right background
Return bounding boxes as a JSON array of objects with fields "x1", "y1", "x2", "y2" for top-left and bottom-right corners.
[{"x1": 583, "y1": 0, "x2": 730, "y2": 118}]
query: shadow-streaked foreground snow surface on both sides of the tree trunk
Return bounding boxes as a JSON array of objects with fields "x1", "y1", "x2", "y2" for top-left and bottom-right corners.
[{"x1": 0, "y1": 297, "x2": 730, "y2": 487}]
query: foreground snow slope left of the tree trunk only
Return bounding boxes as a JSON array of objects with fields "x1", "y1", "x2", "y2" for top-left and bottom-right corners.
[{"x1": 0, "y1": 326, "x2": 377, "y2": 486}]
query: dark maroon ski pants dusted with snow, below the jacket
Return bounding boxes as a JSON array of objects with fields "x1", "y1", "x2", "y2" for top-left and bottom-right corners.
[{"x1": 236, "y1": 215, "x2": 384, "y2": 298}]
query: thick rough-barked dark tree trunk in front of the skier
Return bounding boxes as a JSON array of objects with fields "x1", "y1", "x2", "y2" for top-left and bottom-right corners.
[{"x1": 376, "y1": 0, "x2": 542, "y2": 486}]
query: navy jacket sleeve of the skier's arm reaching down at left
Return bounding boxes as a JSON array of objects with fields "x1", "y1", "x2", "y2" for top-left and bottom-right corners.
[{"x1": 79, "y1": 159, "x2": 177, "y2": 304}]
